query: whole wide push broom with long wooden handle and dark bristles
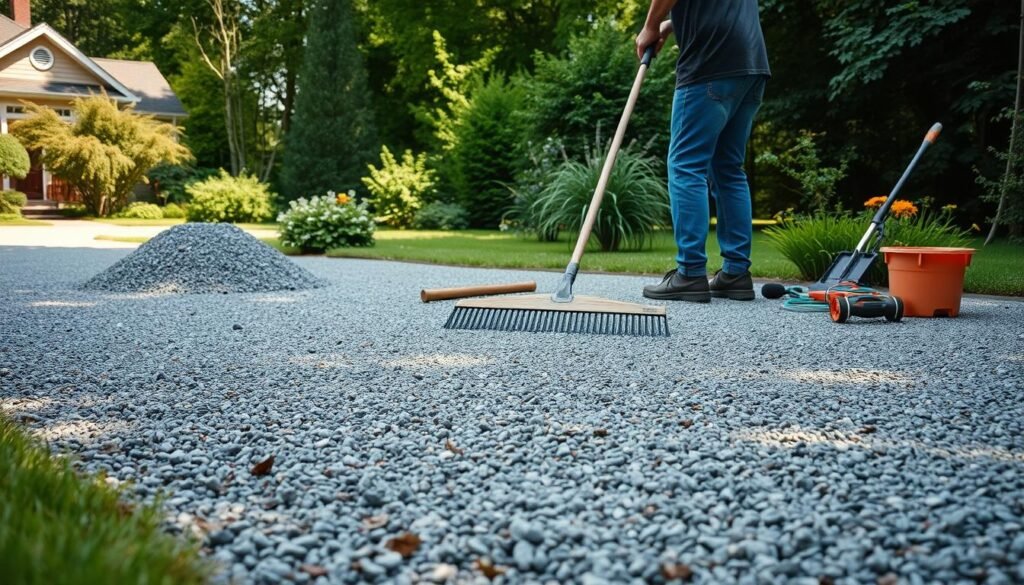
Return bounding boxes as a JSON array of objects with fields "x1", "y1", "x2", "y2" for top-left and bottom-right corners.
[{"x1": 444, "y1": 46, "x2": 669, "y2": 337}]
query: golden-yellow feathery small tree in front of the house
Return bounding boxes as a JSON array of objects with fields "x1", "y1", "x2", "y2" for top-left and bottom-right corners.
[{"x1": 11, "y1": 95, "x2": 190, "y2": 216}]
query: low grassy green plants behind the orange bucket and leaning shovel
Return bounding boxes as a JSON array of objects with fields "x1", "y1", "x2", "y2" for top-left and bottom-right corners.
[{"x1": 764, "y1": 200, "x2": 969, "y2": 286}]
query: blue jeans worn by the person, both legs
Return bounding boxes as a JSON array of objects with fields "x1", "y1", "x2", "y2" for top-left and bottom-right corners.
[{"x1": 669, "y1": 75, "x2": 767, "y2": 277}]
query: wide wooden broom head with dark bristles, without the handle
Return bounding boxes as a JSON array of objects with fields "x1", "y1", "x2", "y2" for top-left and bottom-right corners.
[{"x1": 444, "y1": 295, "x2": 669, "y2": 337}]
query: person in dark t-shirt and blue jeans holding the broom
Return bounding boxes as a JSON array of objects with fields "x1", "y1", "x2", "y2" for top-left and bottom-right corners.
[{"x1": 636, "y1": 0, "x2": 771, "y2": 302}]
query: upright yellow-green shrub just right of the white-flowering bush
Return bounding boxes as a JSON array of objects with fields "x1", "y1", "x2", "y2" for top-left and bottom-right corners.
[{"x1": 362, "y1": 147, "x2": 434, "y2": 227}]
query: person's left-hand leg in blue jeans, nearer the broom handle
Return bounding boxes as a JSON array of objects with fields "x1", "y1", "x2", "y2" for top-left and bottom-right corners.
[{"x1": 668, "y1": 83, "x2": 729, "y2": 277}]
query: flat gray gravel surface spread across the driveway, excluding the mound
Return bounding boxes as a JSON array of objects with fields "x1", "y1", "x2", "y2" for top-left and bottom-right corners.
[{"x1": 0, "y1": 248, "x2": 1024, "y2": 584}]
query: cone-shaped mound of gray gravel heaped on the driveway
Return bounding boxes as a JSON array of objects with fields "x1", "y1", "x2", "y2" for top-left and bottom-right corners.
[{"x1": 82, "y1": 223, "x2": 324, "y2": 293}]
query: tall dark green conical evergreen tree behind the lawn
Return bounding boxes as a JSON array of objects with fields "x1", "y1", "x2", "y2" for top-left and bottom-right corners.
[{"x1": 280, "y1": 0, "x2": 379, "y2": 199}]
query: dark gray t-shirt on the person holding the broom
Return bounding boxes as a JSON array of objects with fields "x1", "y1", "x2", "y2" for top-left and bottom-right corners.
[{"x1": 672, "y1": 0, "x2": 771, "y2": 87}]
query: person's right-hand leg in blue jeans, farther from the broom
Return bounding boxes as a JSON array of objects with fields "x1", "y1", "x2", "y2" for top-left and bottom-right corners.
[{"x1": 711, "y1": 76, "x2": 765, "y2": 276}]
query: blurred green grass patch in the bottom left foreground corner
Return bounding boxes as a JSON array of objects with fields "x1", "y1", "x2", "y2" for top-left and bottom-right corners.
[{"x1": 0, "y1": 414, "x2": 212, "y2": 585}]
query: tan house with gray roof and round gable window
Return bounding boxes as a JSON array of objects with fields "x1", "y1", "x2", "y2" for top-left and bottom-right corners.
[{"x1": 0, "y1": 0, "x2": 186, "y2": 206}]
